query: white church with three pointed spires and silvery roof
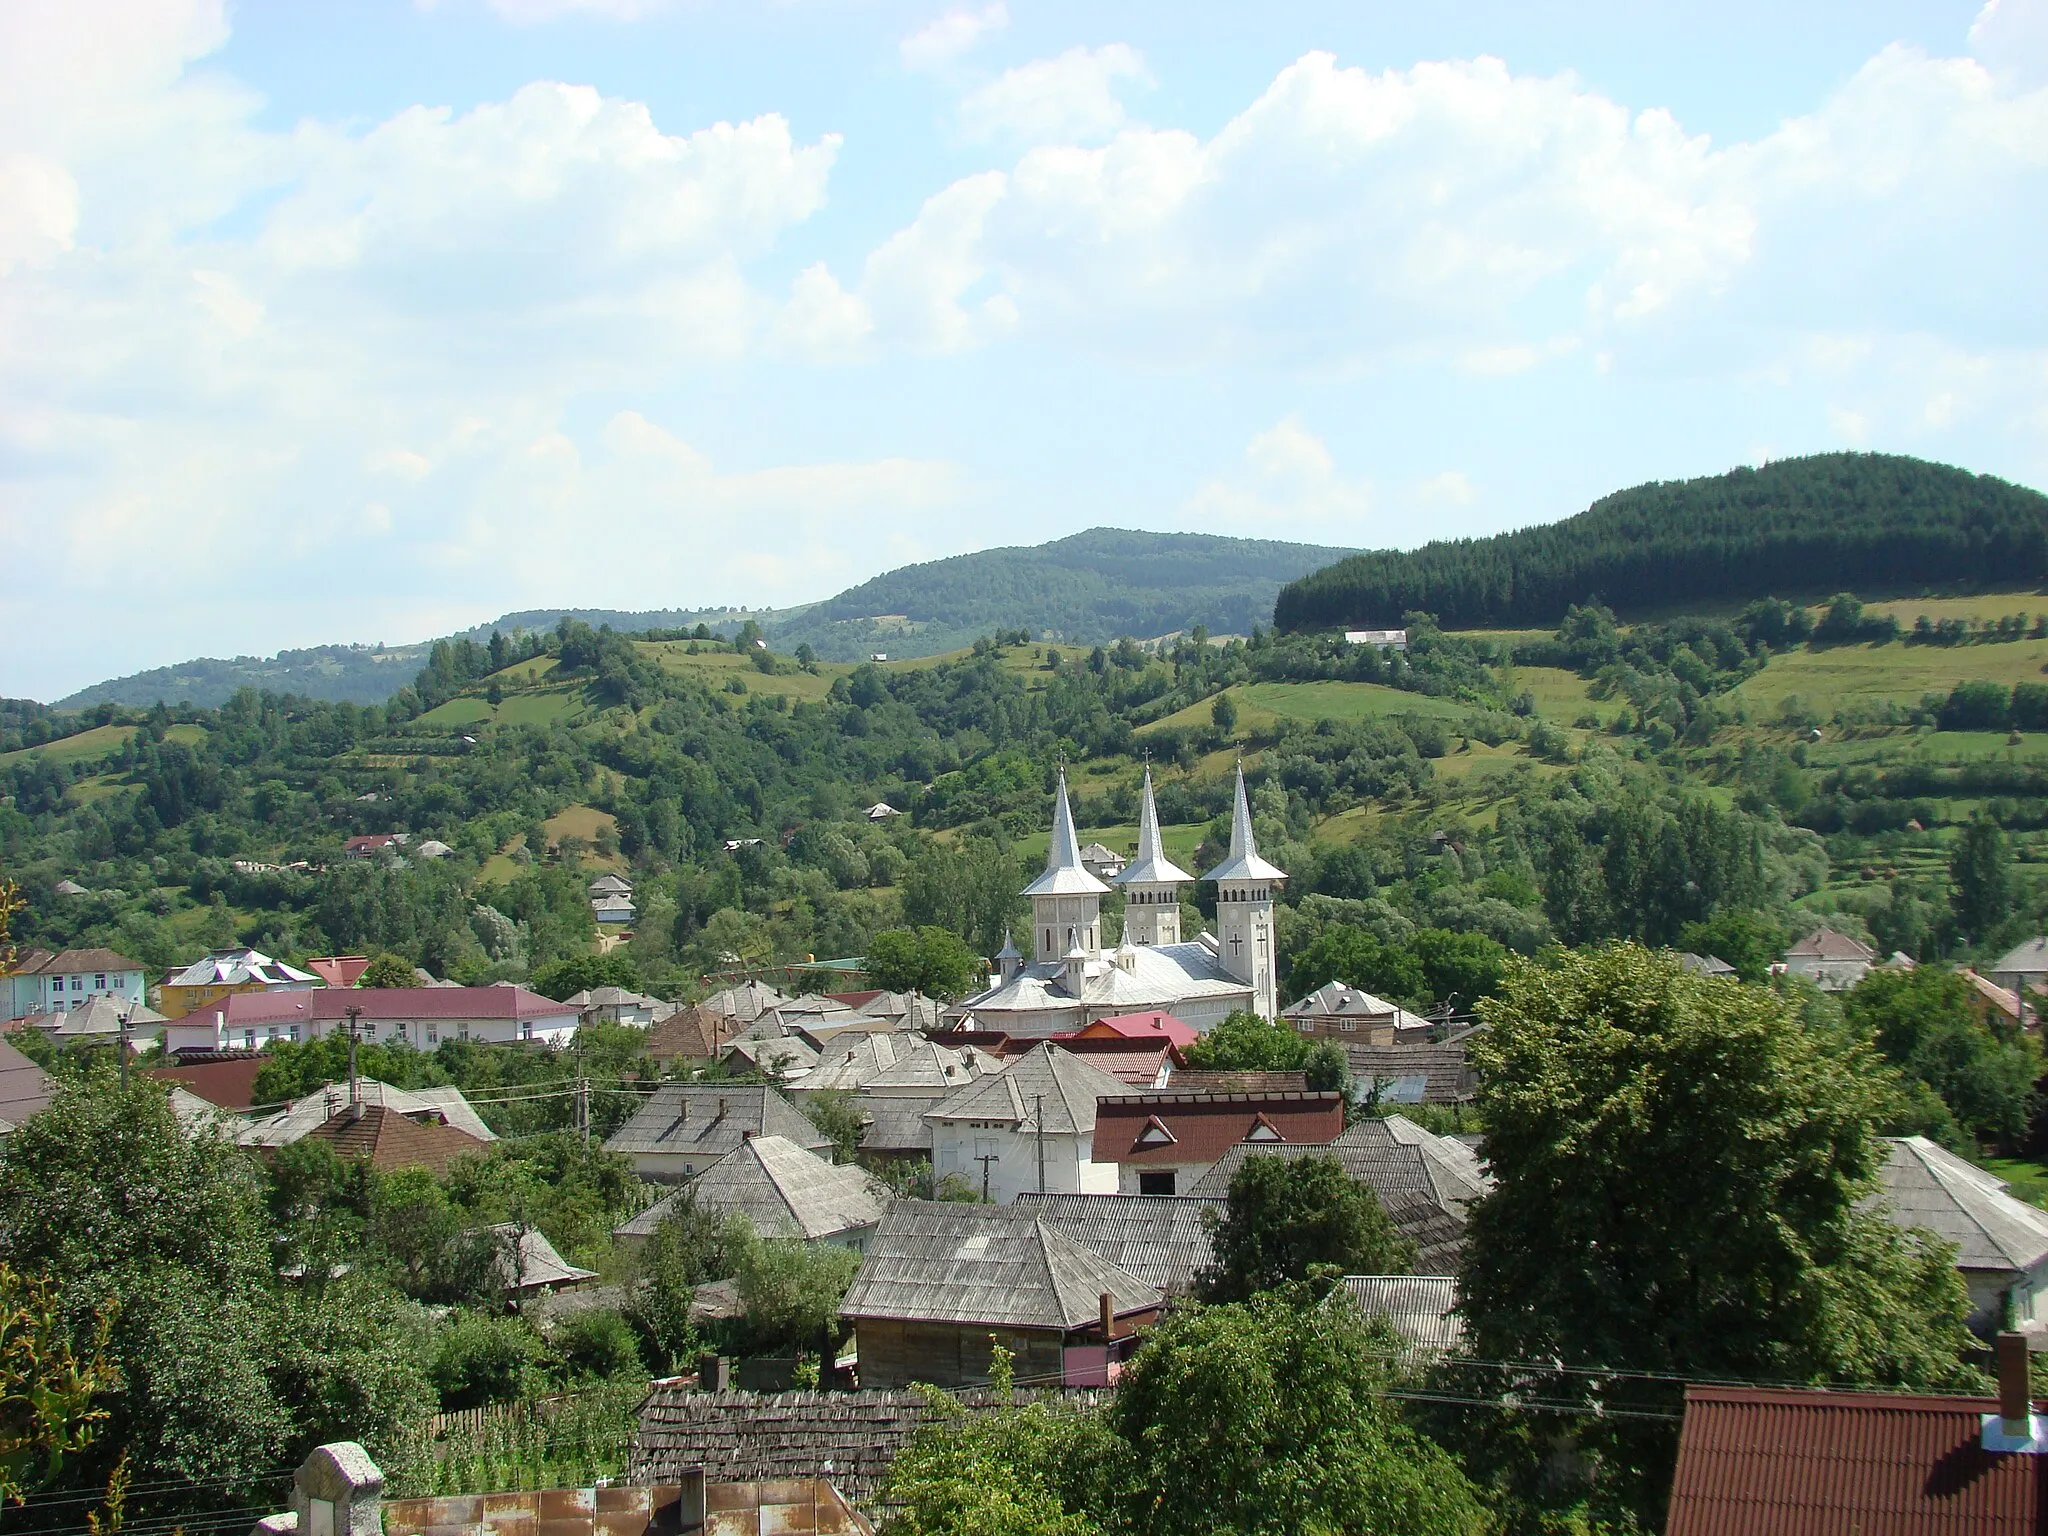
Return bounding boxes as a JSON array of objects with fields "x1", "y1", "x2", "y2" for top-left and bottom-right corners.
[{"x1": 954, "y1": 768, "x2": 1286, "y2": 1038}]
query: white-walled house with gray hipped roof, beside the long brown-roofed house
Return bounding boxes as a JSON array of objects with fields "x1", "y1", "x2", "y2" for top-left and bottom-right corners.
[{"x1": 924, "y1": 1044, "x2": 1130, "y2": 1204}]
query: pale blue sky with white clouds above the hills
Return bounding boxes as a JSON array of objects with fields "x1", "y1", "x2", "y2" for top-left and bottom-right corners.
[{"x1": 0, "y1": 0, "x2": 2048, "y2": 698}]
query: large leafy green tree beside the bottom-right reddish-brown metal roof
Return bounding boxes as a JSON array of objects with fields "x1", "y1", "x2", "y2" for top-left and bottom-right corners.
[{"x1": 1462, "y1": 944, "x2": 1974, "y2": 1524}]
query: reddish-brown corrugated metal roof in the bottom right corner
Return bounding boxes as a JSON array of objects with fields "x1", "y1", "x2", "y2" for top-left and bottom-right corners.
[{"x1": 1665, "y1": 1386, "x2": 2048, "y2": 1536}]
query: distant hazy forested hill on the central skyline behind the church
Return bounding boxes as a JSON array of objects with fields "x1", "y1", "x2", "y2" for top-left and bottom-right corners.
[{"x1": 764, "y1": 528, "x2": 1346, "y2": 662}]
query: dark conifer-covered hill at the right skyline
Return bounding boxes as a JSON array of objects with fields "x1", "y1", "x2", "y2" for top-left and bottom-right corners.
[{"x1": 1274, "y1": 453, "x2": 2048, "y2": 631}]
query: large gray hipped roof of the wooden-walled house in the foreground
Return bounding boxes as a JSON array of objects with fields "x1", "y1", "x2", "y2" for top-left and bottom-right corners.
[{"x1": 840, "y1": 1200, "x2": 1163, "y2": 1331}]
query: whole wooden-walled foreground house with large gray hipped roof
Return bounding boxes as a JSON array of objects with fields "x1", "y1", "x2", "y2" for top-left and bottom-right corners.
[{"x1": 840, "y1": 1200, "x2": 1165, "y2": 1389}]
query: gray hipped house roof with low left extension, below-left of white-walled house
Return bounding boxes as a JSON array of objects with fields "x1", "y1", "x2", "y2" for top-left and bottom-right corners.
[{"x1": 612, "y1": 1137, "x2": 889, "y2": 1253}]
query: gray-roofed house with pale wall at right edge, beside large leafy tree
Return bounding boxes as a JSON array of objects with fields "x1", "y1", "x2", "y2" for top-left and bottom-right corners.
[{"x1": 1866, "y1": 1137, "x2": 2048, "y2": 1337}]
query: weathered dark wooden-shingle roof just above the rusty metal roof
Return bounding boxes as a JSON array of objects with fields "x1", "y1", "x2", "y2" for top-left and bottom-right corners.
[{"x1": 627, "y1": 1386, "x2": 1108, "y2": 1501}]
